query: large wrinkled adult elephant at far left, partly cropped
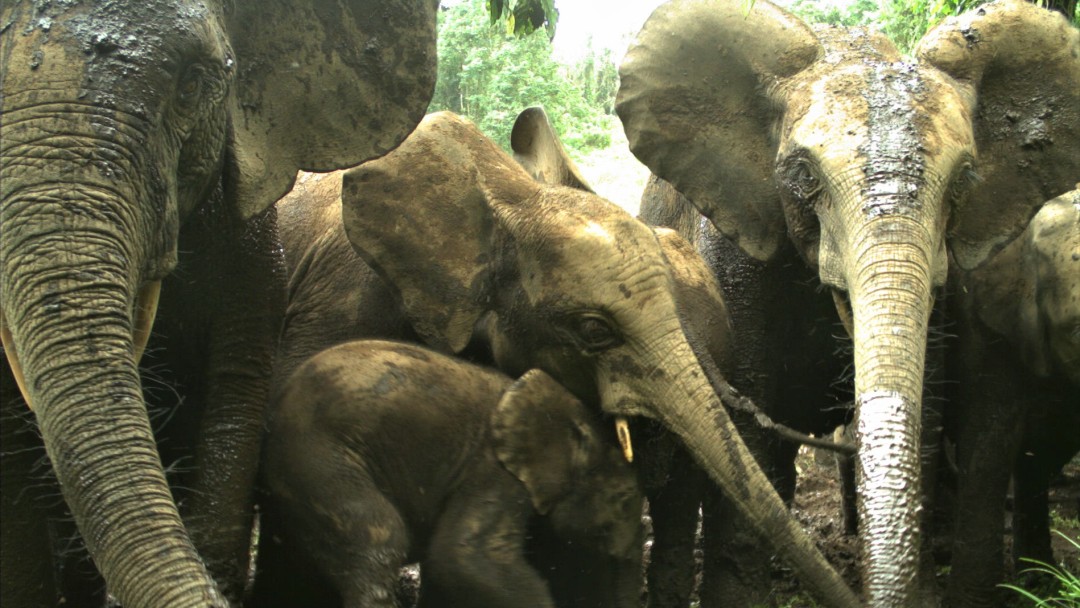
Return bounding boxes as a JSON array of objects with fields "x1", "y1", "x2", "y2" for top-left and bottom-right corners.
[{"x1": 0, "y1": 0, "x2": 436, "y2": 608}]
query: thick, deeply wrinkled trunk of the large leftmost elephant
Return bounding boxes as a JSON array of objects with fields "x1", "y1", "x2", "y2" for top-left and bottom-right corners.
[{"x1": 0, "y1": 187, "x2": 225, "y2": 608}]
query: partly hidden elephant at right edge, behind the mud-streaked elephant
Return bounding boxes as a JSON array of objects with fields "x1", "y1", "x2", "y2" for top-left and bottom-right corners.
[{"x1": 946, "y1": 190, "x2": 1080, "y2": 606}]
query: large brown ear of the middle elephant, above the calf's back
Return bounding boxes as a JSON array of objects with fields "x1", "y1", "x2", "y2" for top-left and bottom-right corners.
[{"x1": 341, "y1": 112, "x2": 540, "y2": 353}]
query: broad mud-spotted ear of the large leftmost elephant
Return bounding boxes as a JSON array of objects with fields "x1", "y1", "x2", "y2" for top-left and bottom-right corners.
[{"x1": 225, "y1": 0, "x2": 438, "y2": 217}]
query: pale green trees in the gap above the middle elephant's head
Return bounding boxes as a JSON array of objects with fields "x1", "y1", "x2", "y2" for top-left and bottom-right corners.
[{"x1": 429, "y1": 0, "x2": 617, "y2": 151}]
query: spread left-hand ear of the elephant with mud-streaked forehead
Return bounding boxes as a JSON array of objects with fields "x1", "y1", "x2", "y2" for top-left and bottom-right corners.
[{"x1": 616, "y1": 0, "x2": 822, "y2": 259}]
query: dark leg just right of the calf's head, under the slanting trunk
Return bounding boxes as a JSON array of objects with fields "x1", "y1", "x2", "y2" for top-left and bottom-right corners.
[{"x1": 647, "y1": 449, "x2": 708, "y2": 608}]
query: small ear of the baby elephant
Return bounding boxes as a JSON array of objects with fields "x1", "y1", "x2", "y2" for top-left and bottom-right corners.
[{"x1": 491, "y1": 369, "x2": 602, "y2": 515}]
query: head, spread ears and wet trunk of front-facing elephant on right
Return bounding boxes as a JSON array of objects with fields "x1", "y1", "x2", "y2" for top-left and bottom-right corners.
[{"x1": 617, "y1": 0, "x2": 1080, "y2": 606}]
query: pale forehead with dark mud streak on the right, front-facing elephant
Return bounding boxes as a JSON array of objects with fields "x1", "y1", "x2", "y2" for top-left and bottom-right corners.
[{"x1": 781, "y1": 60, "x2": 974, "y2": 214}]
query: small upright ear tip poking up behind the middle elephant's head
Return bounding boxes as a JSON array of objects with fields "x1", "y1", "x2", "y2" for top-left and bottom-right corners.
[{"x1": 510, "y1": 107, "x2": 593, "y2": 192}]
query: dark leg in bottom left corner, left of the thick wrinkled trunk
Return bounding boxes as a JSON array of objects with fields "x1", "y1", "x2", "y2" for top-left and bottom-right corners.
[{"x1": 0, "y1": 377, "x2": 60, "y2": 606}]
